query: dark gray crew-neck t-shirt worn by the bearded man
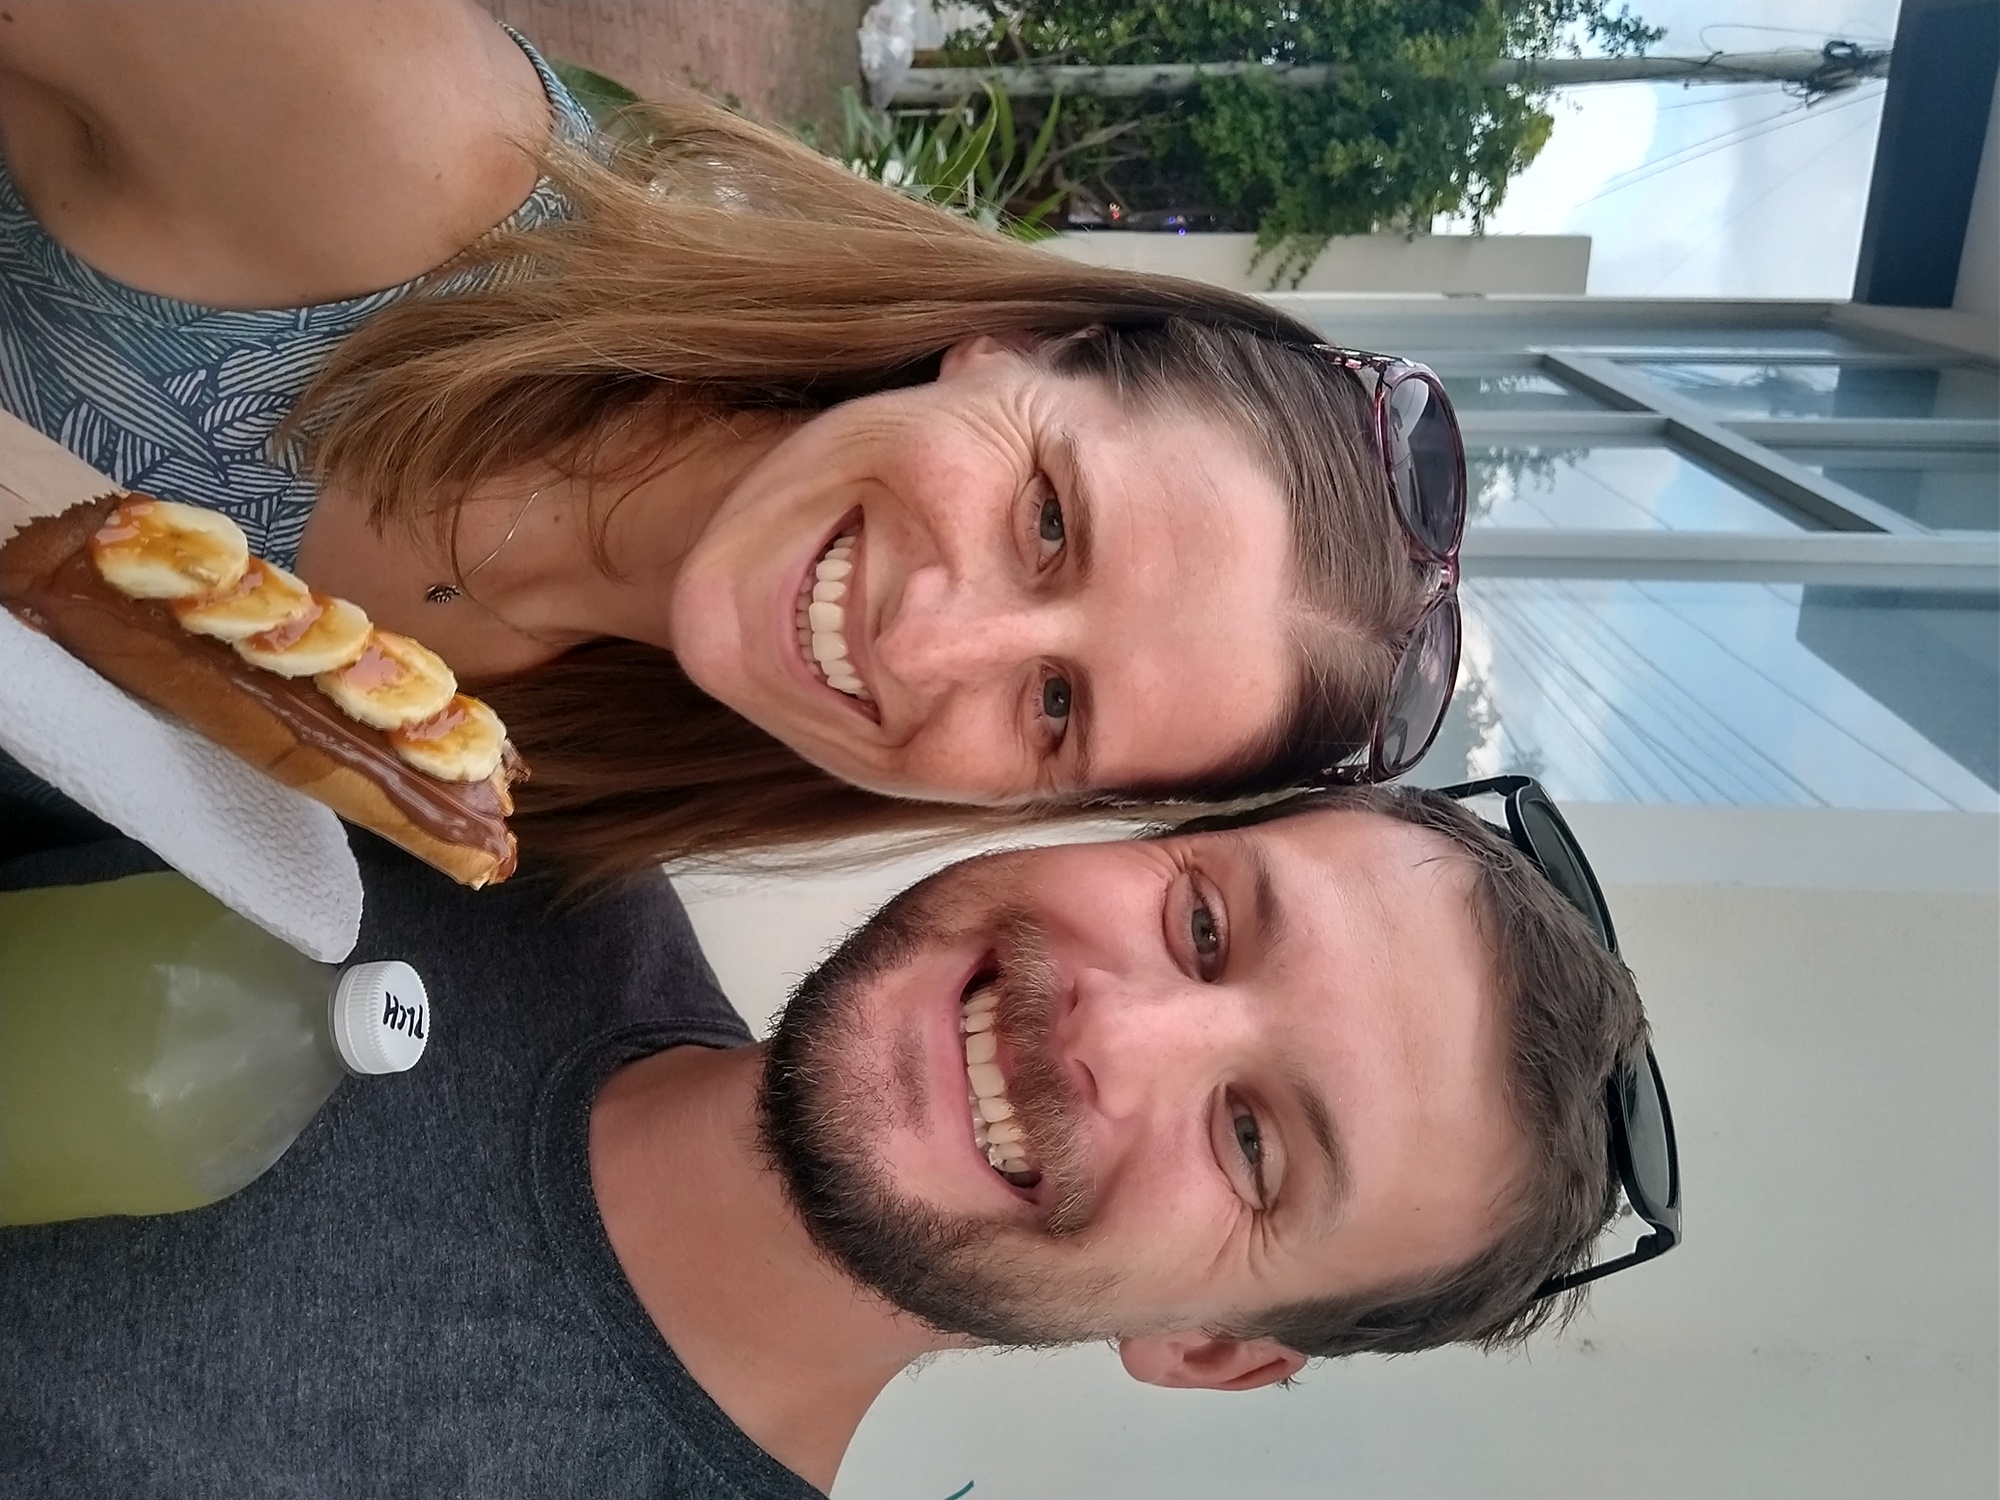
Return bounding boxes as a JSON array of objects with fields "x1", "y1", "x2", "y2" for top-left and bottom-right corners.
[{"x1": 0, "y1": 836, "x2": 818, "y2": 1500}]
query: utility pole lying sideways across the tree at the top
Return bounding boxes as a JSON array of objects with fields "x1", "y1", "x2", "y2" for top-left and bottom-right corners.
[{"x1": 890, "y1": 42, "x2": 1890, "y2": 108}]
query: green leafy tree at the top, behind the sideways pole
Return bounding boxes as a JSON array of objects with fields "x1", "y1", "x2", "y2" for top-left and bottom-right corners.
[{"x1": 946, "y1": 0, "x2": 1662, "y2": 284}]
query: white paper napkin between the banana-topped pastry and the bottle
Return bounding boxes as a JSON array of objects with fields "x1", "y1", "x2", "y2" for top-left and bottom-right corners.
[{"x1": 0, "y1": 610, "x2": 362, "y2": 964}]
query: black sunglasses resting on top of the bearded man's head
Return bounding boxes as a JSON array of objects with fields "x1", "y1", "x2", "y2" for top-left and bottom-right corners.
[{"x1": 1438, "y1": 776, "x2": 1680, "y2": 1300}]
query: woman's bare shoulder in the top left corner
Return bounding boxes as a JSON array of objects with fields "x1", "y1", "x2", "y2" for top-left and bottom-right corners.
[{"x1": 0, "y1": 0, "x2": 548, "y2": 308}]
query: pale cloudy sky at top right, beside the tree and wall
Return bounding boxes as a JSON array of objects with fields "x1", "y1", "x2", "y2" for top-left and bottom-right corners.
[{"x1": 1438, "y1": 0, "x2": 1896, "y2": 298}]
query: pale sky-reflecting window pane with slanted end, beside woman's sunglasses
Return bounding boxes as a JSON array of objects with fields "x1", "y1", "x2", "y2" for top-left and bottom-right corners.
[{"x1": 1466, "y1": 444, "x2": 1806, "y2": 532}]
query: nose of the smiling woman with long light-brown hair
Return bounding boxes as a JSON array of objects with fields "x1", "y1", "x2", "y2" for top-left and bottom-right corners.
[{"x1": 874, "y1": 566, "x2": 1060, "y2": 696}]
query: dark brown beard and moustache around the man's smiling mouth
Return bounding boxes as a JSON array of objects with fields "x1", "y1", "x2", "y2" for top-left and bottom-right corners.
[{"x1": 758, "y1": 864, "x2": 1114, "y2": 1346}]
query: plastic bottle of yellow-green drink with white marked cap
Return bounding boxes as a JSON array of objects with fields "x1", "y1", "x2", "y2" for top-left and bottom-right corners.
[{"x1": 0, "y1": 872, "x2": 430, "y2": 1224}]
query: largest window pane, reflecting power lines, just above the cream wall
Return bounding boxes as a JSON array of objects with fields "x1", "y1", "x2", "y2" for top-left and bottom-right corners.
[{"x1": 1414, "y1": 578, "x2": 2000, "y2": 812}]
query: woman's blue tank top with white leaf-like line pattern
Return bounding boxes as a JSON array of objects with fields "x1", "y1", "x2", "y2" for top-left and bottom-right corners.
[{"x1": 0, "y1": 28, "x2": 592, "y2": 566}]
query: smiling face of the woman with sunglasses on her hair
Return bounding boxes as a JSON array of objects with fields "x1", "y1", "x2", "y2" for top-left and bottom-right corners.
[{"x1": 670, "y1": 338, "x2": 1296, "y2": 804}]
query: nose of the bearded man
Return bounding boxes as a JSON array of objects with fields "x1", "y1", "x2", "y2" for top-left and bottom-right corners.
[{"x1": 1060, "y1": 968, "x2": 1252, "y2": 1120}]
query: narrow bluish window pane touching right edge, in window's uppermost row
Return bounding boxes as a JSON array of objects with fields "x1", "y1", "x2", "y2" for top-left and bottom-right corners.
[{"x1": 1632, "y1": 364, "x2": 2000, "y2": 420}]
